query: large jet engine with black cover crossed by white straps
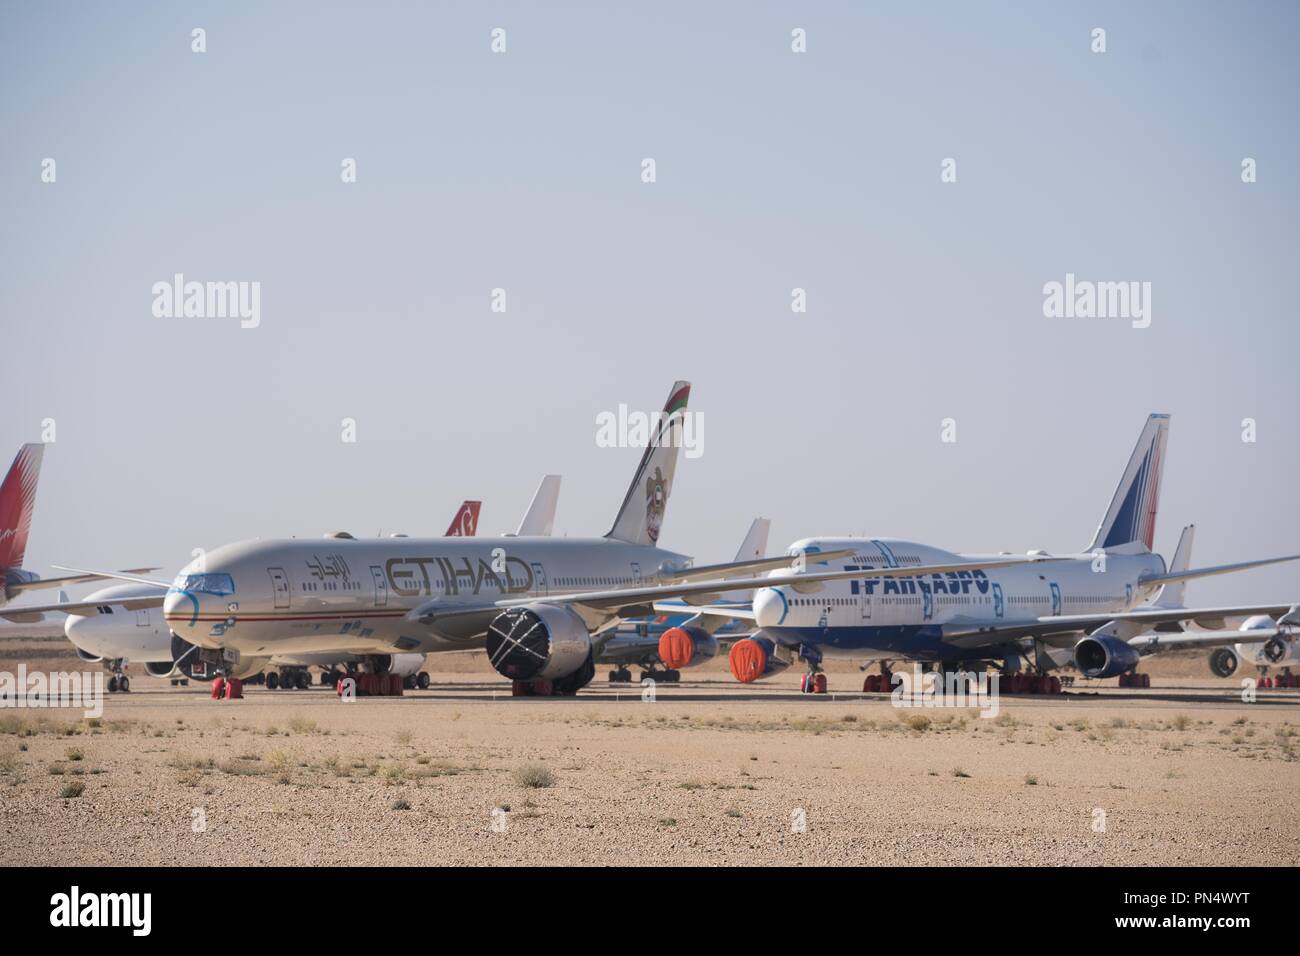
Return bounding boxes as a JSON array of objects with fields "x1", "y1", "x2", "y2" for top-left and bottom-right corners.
[{"x1": 488, "y1": 604, "x2": 595, "y2": 691}]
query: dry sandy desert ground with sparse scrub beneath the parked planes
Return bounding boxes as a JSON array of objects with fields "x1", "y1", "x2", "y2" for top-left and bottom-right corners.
[{"x1": 0, "y1": 632, "x2": 1300, "y2": 865}]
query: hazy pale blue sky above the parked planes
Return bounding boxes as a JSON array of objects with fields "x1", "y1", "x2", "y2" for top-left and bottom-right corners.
[{"x1": 0, "y1": 0, "x2": 1300, "y2": 602}]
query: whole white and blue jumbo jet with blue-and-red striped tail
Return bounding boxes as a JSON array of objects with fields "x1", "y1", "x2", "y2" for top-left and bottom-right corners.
[{"x1": 696, "y1": 415, "x2": 1300, "y2": 689}]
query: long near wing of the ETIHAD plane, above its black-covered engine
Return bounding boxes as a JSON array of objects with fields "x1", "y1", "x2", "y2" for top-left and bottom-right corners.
[{"x1": 406, "y1": 553, "x2": 1060, "y2": 628}]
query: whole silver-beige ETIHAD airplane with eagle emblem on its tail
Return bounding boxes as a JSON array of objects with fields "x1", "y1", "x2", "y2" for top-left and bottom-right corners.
[{"x1": 38, "y1": 382, "x2": 1055, "y2": 695}]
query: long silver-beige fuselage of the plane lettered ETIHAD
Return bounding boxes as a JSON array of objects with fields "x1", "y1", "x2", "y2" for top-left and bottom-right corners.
[{"x1": 164, "y1": 537, "x2": 690, "y2": 657}]
